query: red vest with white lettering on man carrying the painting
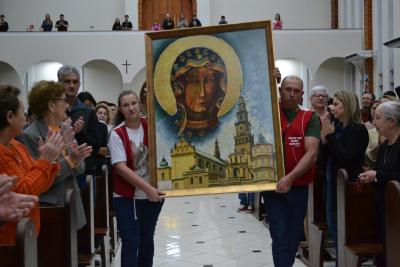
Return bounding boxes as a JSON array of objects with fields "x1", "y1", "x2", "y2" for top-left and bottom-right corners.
[{"x1": 280, "y1": 108, "x2": 317, "y2": 185}]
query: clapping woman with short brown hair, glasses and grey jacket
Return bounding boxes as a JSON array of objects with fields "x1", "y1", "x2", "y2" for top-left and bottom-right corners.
[{"x1": 19, "y1": 81, "x2": 92, "y2": 229}]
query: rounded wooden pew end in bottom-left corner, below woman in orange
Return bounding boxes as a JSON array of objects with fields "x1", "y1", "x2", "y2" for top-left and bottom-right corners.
[{"x1": 0, "y1": 218, "x2": 38, "y2": 267}]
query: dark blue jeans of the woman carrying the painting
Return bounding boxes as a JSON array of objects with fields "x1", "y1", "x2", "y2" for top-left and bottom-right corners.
[{"x1": 113, "y1": 197, "x2": 164, "y2": 267}]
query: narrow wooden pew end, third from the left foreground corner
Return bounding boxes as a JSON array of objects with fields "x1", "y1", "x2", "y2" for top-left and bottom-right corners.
[{"x1": 78, "y1": 175, "x2": 95, "y2": 267}]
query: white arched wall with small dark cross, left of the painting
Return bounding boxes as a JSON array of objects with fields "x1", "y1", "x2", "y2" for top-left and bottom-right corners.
[{"x1": 0, "y1": 32, "x2": 145, "y2": 86}]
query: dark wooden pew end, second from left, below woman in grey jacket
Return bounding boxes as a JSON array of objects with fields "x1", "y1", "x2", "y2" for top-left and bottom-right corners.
[{"x1": 38, "y1": 189, "x2": 79, "y2": 267}]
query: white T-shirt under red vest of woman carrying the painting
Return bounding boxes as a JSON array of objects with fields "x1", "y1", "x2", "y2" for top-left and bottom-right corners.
[{"x1": 108, "y1": 123, "x2": 150, "y2": 199}]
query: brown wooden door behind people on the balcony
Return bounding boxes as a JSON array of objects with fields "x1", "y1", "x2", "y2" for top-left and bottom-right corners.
[{"x1": 139, "y1": 0, "x2": 197, "y2": 30}]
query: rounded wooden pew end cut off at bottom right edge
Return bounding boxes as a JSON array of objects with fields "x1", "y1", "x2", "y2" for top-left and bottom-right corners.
[{"x1": 385, "y1": 181, "x2": 400, "y2": 267}]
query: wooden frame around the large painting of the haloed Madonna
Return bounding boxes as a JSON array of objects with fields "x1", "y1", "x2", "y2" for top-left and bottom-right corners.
[{"x1": 145, "y1": 21, "x2": 285, "y2": 193}]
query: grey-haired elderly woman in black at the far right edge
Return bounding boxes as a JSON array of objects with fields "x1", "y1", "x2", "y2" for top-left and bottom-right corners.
[{"x1": 359, "y1": 101, "x2": 400, "y2": 258}]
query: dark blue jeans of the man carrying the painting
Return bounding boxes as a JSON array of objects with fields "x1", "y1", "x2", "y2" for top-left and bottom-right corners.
[{"x1": 262, "y1": 186, "x2": 308, "y2": 267}]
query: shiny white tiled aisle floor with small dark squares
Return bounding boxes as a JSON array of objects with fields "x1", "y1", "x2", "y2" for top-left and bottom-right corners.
[{"x1": 114, "y1": 194, "x2": 304, "y2": 267}]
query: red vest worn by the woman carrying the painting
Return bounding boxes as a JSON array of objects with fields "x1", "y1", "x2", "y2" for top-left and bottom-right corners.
[{"x1": 113, "y1": 118, "x2": 148, "y2": 198}]
